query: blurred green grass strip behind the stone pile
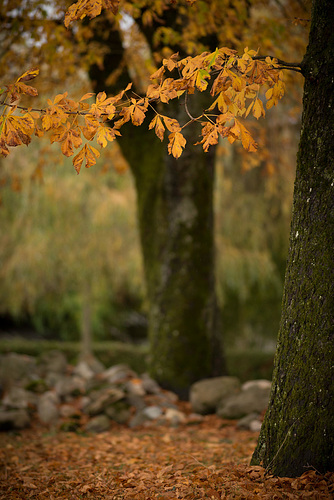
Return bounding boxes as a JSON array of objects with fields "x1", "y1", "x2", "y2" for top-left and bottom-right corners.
[{"x1": 0, "y1": 337, "x2": 274, "y2": 382}]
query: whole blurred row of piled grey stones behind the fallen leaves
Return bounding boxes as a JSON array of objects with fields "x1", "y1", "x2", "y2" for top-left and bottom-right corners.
[{"x1": 0, "y1": 351, "x2": 271, "y2": 432}]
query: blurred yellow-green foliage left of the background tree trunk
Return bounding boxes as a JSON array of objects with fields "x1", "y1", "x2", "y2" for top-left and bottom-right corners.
[{"x1": 0, "y1": 139, "x2": 143, "y2": 340}]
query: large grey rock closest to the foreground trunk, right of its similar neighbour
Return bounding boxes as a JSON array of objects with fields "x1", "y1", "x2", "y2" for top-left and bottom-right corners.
[{"x1": 217, "y1": 381, "x2": 271, "y2": 419}]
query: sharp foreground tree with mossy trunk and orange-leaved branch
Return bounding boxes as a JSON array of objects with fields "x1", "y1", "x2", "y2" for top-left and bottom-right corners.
[{"x1": 2, "y1": 0, "x2": 334, "y2": 476}]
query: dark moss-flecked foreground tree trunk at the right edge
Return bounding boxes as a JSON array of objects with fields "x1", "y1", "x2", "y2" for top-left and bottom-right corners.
[{"x1": 252, "y1": 0, "x2": 334, "y2": 477}]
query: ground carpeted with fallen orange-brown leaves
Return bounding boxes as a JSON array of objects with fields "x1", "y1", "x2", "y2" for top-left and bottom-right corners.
[{"x1": 0, "y1": 406, "x2": 334, "y2": 500}]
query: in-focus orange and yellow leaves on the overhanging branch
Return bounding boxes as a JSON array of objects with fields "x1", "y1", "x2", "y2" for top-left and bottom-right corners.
[{"x1": 0, "y1": 47, "x2": 285, "y2": 166}]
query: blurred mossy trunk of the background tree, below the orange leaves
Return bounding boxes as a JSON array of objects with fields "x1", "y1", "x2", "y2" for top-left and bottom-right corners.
[{"x1": 119, "y1": 95, "x2": 225, "y2": 397}]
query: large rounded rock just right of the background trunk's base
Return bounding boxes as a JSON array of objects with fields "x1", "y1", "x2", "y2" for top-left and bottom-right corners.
[{"x1": 190, "y1": 377, "x2": 240, "y2": 415}]
